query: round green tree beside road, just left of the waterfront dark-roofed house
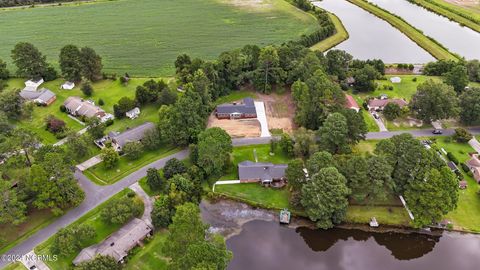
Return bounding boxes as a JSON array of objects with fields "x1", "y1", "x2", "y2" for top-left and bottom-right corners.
[{"x1": 197, "y1": 127, "x2": 233, "y2": 176}]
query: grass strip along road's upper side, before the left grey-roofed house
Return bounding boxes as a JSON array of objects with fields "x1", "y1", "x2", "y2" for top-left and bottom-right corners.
[{"x1": 84, "y1": 146, "x2": 180, "y2": 185}]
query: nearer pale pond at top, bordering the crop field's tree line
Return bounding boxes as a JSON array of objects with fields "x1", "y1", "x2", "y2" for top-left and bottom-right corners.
[{"x1": 313, "y1": 0, "x2": 434, "y2": 63}]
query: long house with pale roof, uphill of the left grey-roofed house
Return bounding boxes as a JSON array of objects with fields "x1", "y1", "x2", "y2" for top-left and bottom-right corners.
[{"x1": 63, "y1": 96, "x2": 114, "y2": 122}]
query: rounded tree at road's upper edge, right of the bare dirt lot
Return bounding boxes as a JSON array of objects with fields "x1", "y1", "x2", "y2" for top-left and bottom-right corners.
[{"x1": 318, "y1": 113, "x2": 351, "y2": 154}]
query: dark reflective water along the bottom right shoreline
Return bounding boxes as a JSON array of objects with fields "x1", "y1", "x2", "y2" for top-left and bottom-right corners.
[{"x1": 201, "y1": 198, "x2": 480, "y2": 270}]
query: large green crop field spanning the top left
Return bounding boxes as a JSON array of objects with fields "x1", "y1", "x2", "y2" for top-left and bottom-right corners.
[{"x1": 0, "y1": 0, "x2": 318, "y2": 76}]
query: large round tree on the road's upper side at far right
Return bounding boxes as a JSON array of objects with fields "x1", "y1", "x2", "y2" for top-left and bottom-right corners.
[{"x1": 410, "y1": 80, "x2": 459, "y2": 123}]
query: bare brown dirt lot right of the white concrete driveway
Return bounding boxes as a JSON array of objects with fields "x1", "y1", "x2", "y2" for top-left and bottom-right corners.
[{"x1": 257, "y1": 92, "x2": 296, "y2": 133}]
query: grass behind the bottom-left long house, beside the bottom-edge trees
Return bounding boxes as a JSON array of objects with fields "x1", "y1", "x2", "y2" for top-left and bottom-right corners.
[{"x1": 125, "y1": 231, "x2": 168, "y2": 270}]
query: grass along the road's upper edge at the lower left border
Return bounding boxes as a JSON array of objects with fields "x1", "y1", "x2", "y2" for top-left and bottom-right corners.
[{"x1": 0, "y1": 209, "x2": 57, "y2": 254}]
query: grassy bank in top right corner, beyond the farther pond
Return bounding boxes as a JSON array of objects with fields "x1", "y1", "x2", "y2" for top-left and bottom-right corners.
[{"x1": 409, "y1": 0, "x2": 480, "y2": 33}]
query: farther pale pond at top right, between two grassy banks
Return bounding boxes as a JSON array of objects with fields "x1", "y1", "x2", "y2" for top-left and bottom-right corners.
[{"x1": 369, "y1": 0, "x2": 480, "y2": 59}]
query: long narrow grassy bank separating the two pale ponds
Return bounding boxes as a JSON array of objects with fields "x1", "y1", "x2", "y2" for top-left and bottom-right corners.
[{"x1": 347, "y1": 0, "x2": 458, "y2": 60}]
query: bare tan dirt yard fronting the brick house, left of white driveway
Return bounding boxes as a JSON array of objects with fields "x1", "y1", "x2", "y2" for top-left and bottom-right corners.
[{"x1": 208, "y1": 114, "x2": 261, "y2": 138}]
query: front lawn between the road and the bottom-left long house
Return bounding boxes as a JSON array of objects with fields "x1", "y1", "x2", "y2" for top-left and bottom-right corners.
[{"x1": 35, "y1": 189, "x2": 137, "y2": 270}]
